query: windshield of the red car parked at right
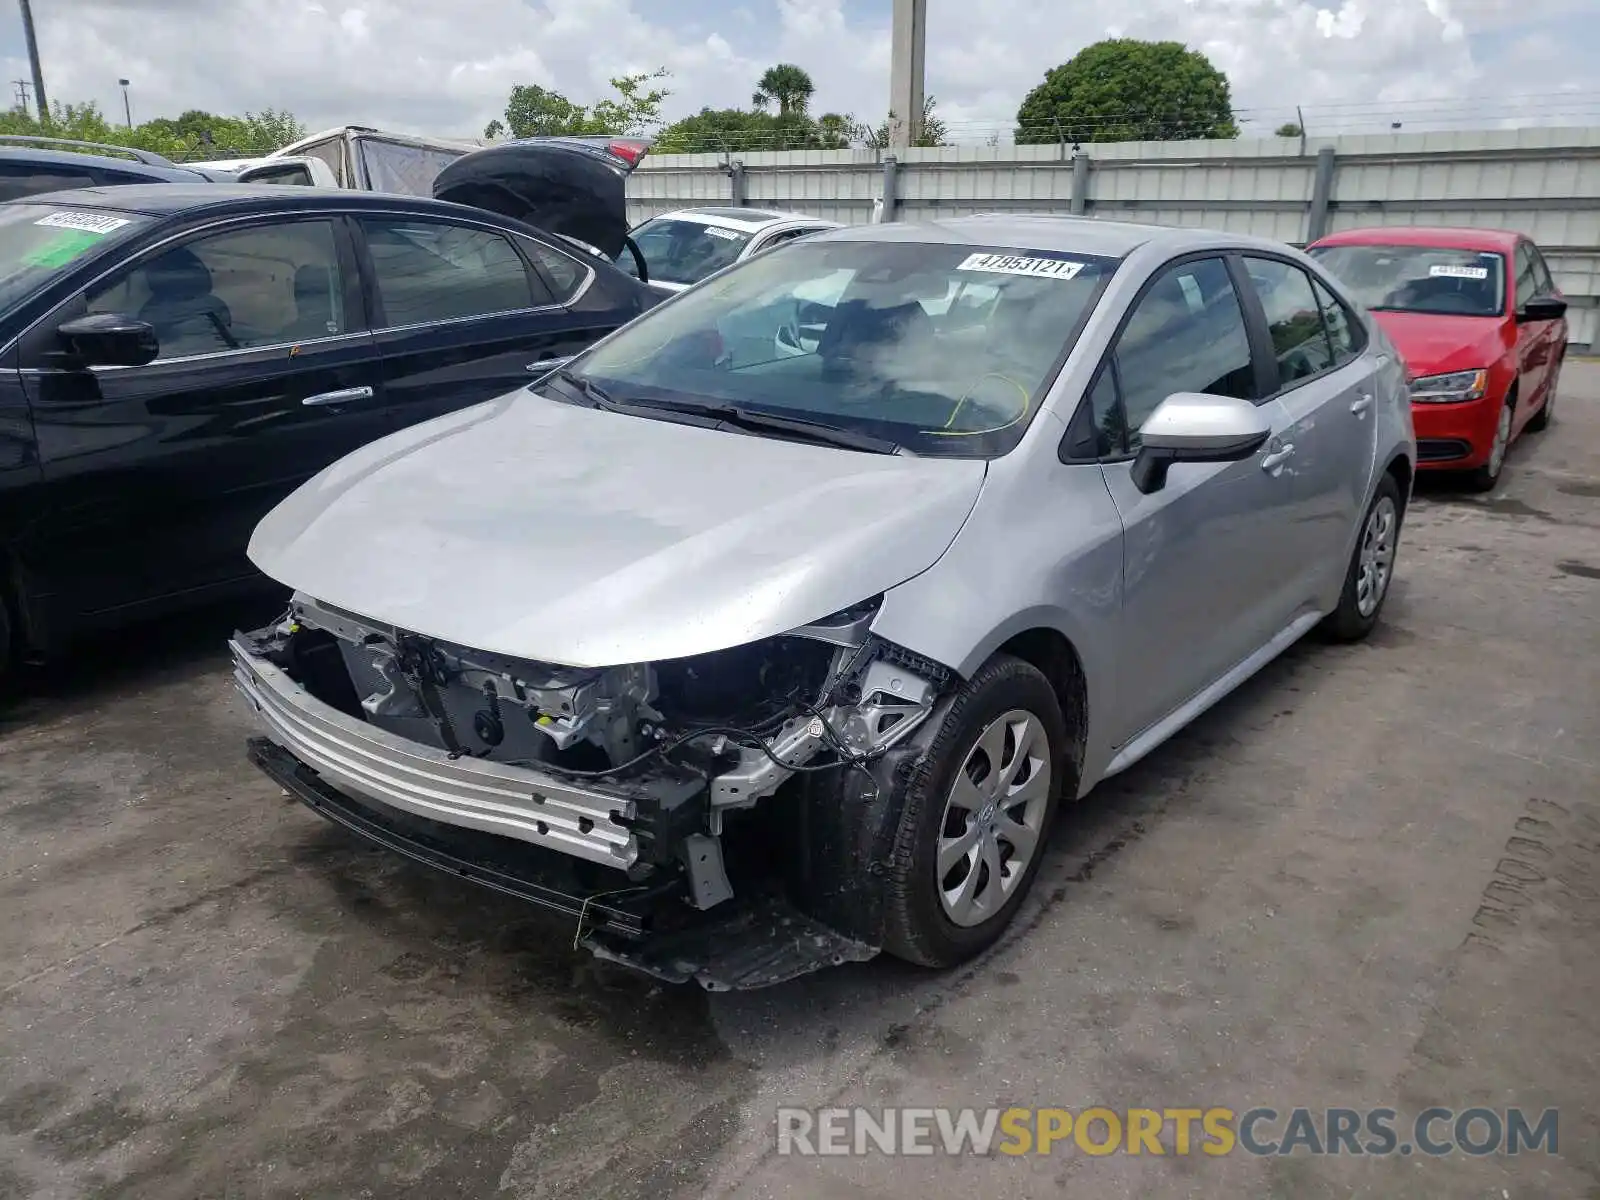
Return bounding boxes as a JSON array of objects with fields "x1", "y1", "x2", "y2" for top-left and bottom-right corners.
[{"x1": 1310, "y1": 246, "x2": 1506, "y2": 317}]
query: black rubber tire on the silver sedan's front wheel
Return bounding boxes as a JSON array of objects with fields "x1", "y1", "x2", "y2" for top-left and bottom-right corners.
[{"x1": 883, "y1": 654, "x2": 1078, "y2": 966}]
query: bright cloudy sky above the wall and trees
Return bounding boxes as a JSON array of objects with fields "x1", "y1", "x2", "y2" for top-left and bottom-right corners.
[{"x1": 0, "y1": 0, "x2": 1600, "y2": 141}]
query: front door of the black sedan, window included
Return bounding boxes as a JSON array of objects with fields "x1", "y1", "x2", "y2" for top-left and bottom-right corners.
[{"x1": 21, "y1": 218, "x2": 389, "y2": 622}]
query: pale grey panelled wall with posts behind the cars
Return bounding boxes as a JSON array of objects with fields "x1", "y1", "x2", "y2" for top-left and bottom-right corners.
[{"x1": 629, "y1": 128, "x2": 1600, "y2": 347}]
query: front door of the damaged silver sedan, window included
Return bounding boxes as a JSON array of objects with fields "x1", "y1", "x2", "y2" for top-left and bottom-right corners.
[{"x1": 1091, "y1": 258, "x2": 1294, "y2": 744}]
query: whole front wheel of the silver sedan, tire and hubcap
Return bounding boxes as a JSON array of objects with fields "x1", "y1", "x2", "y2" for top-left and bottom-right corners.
[{"x1": 883, "y1": 654, "x2": 1078, "y2": 966}]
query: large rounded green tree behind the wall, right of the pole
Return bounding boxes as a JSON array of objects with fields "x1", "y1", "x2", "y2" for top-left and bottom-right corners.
[{"x1": 1016, "y1": 38, "x2": 1238, "y2": 144}]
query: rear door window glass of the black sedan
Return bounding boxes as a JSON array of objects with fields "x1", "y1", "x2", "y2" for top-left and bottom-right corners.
[{"x1": 362, "y1": 218, "x2": 550, "y2": 326}]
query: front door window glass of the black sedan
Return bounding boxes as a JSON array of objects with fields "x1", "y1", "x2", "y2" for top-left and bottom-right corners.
[{"x1": 86, "y1": 221, "x2": 347, "y2": 358}]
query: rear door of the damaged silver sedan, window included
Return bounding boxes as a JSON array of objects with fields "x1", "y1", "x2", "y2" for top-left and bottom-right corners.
[{"x1": 1242, "y1": 254, "x2": 1378, "y2": 602}]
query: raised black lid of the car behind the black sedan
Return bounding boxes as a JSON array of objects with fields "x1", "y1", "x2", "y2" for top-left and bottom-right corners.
[{"x1": 434, "y1": 138, "x2": 646, "y2": 259}]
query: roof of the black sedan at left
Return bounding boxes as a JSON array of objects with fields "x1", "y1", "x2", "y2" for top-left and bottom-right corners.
[{"x1": 0, "y1": 181, "x2": 505, "y2": 226}]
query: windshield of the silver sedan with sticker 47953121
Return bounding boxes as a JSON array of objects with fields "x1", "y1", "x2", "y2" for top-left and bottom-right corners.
[{"x1": 573, "y1": 240, "x2": 1118, "y2": 458}]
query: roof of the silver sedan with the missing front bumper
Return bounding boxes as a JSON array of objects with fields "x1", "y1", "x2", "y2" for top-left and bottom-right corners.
[{"x1": 816, "y1": 213, "x2": 1283, "y2": 258}]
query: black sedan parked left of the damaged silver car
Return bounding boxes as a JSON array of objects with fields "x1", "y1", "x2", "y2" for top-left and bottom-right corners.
[{"x1": 0, "y1": 184, "x2": 659, "y2": 674}]
